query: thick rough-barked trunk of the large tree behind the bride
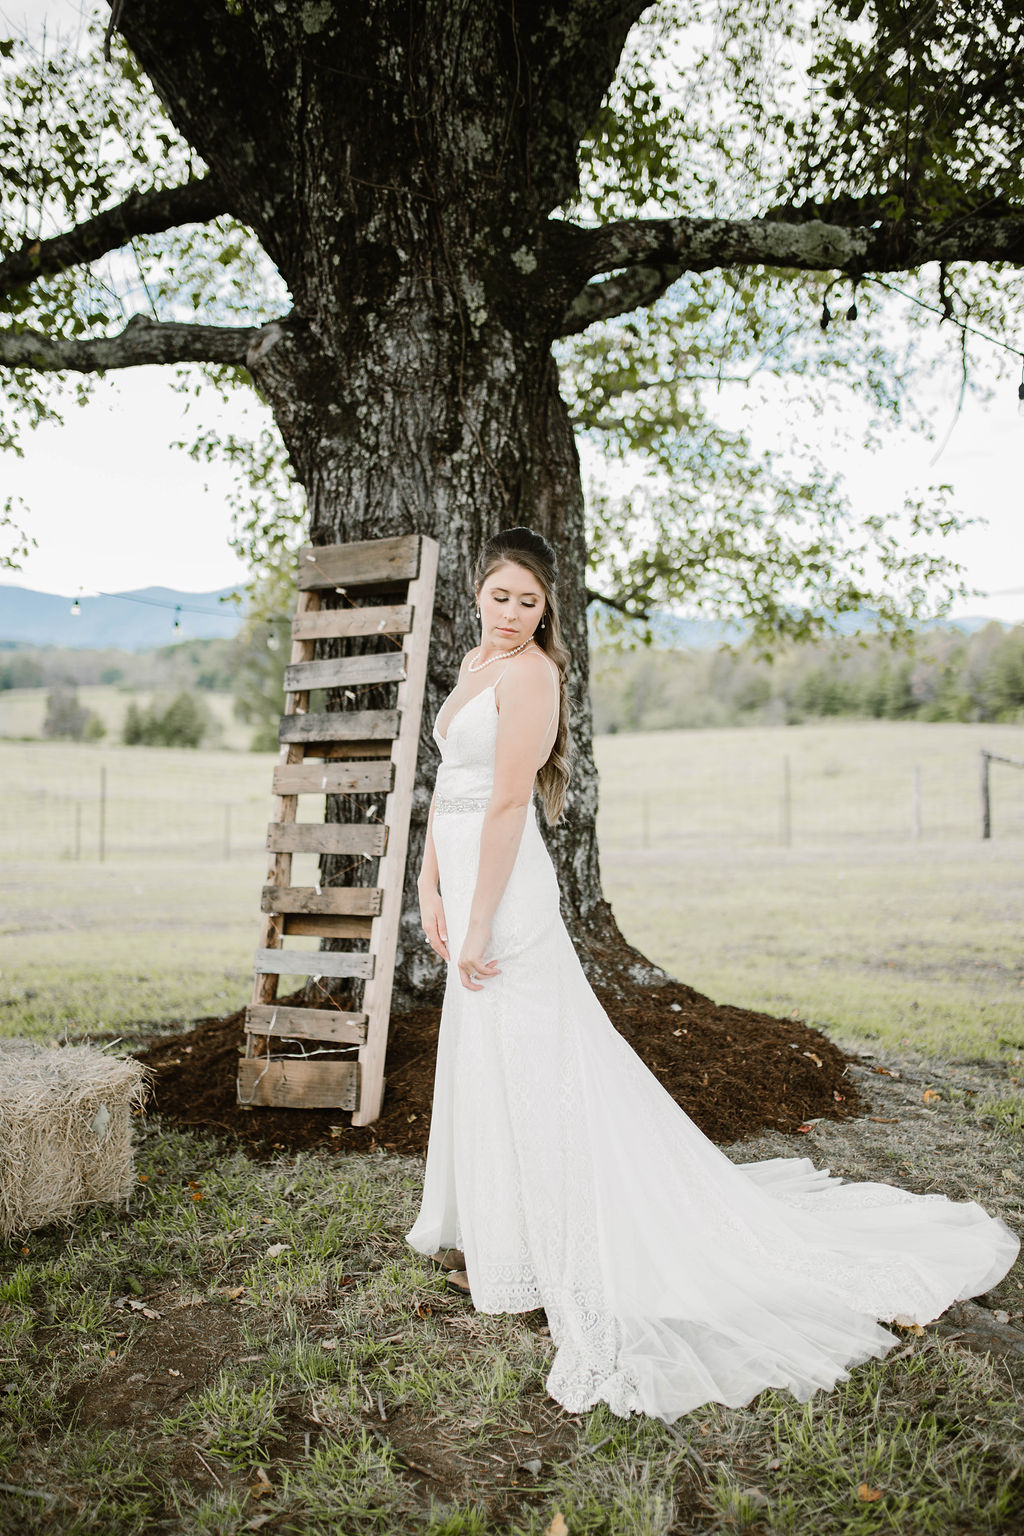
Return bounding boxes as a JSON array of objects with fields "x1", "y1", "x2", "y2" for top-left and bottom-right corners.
[{"x1": 123, "y1": 0, "x2": 660, "y2": 1001}]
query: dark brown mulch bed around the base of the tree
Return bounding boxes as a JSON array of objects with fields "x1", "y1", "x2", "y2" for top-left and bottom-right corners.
[{"x1": 137, "y1": 982, "x2": 860, "y2": 1157}]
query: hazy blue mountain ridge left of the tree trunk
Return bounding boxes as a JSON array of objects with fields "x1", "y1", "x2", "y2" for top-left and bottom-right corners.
[{"x1": 0, "y1": 587, "x2": 244, "y2": 651}]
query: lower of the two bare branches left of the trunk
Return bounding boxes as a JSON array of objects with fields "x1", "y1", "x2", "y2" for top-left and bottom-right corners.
[{"x1": 0, "y1": 315, "x2": 268, "y2": 373}]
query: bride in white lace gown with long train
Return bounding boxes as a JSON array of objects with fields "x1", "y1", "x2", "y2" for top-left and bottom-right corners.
[{"x1": 407, "y1": 528, "x2": 1019, "y2": 1422}]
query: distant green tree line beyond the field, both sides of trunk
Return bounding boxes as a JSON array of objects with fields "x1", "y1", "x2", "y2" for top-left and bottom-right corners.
[{"x1": 10, "y1": 621, "x2": 1024, "y2": 751}]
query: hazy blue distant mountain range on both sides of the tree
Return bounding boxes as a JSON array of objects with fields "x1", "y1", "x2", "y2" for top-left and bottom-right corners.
[{"x1": 0, "y1": 587, "x2": 992, "y2": 651}]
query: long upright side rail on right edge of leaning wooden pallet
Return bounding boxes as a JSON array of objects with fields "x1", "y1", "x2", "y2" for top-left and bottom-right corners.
[{"x1": 352, "y1": 536, "x2": 438, "y2": 1126}]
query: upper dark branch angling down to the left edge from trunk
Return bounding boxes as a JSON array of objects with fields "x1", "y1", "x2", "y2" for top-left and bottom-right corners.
[{"x1": 0, "y1": 175, "x2": 227, "y2": 293}]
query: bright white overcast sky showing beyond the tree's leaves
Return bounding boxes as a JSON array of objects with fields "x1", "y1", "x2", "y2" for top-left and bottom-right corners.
[{"x1": 0, "y1": 0, "x2": 1024, "y2": 622}]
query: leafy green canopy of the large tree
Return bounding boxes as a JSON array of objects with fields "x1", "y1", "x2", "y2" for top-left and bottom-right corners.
[{"x1": 0, "y1": 0, "x2": 1024, "y2": 641}]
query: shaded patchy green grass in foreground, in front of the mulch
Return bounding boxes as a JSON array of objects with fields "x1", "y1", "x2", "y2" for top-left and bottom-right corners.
[{"x1": 0, "y1": 1127, "x2": 1024, "y2": 1536}]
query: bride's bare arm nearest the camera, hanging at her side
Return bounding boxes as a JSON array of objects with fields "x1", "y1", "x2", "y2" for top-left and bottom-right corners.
[{"x1": 459, "y1": 657, "x2": 551, "y2": 992}]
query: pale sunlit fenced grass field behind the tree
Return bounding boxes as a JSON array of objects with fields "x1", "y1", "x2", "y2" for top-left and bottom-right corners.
[{"x1": 0, "y1": 723, "x2": 1024, "y2": 1057}]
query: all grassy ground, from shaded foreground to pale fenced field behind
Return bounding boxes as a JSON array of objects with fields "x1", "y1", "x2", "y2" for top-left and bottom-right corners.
[{"x1": 0, "y1": 725, "x2": 1024, "y2": 1536}]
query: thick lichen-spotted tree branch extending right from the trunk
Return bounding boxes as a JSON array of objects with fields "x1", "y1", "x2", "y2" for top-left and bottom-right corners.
[{"x1": 562, "y1": 210, "x2": 1024, "y2": 335}]
